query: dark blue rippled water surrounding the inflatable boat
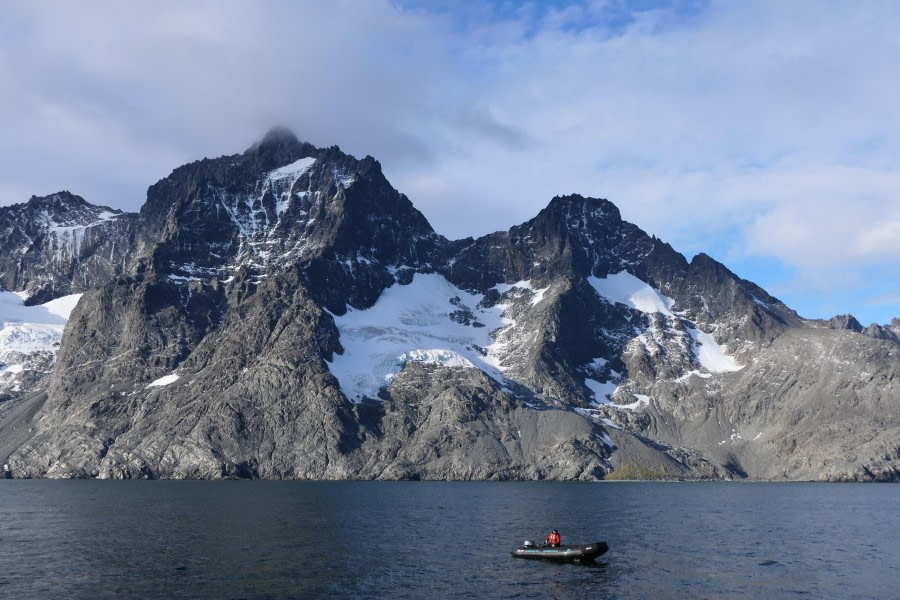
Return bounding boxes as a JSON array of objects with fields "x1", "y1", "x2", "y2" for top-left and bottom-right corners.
[{"x1": 0, "y1": 480, "x2": 900, "y2": 600}]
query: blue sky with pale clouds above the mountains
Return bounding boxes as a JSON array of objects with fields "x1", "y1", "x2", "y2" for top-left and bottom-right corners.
[{"x1": 0, "y1": 0, "x2": 900, "y2": 325}]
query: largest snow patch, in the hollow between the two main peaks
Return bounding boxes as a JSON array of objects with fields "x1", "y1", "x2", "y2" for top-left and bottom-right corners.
[{"x1": 329, "y1": 274, "x2": 513, "y2": 402}]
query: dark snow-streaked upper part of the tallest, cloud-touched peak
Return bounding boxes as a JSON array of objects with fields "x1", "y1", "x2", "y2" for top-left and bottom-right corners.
[{"x1": 125, "y1": 128, "x2": 439, "y2": 313}]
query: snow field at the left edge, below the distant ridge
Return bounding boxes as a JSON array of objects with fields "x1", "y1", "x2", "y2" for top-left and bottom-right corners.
[{"x1": 0, "y1": 292, "x2": 81, "y2": 395}]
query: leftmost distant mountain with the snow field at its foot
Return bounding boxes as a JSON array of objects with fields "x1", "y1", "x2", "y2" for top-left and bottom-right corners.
[{"x1": 0, "y1": 192, "x2": 136, "y2": 402}]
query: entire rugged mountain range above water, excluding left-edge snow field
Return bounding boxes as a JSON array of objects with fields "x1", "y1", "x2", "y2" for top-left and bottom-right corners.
[{"x1": 0, "y1": 130, "x2": 900, "y2": 480}]
